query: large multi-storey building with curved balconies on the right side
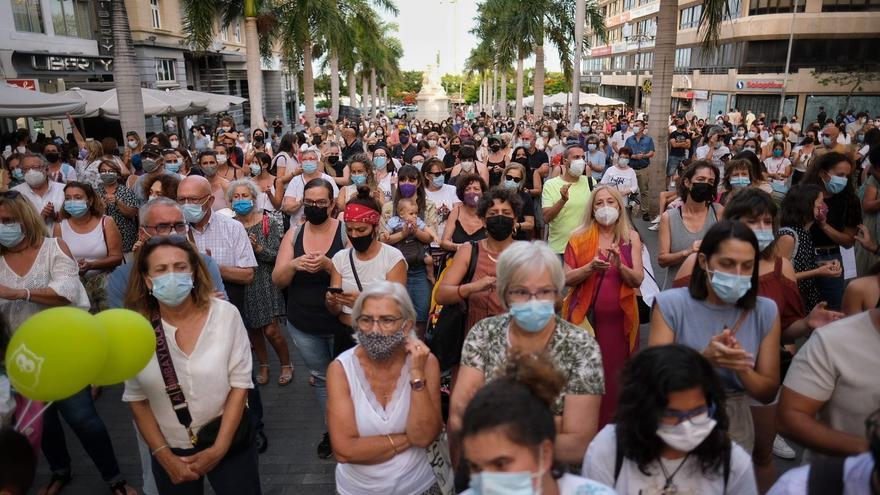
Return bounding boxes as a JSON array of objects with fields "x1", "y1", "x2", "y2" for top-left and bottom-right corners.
[{"x1": 581, "y1": 0, "x2": 880, "y2": 121}]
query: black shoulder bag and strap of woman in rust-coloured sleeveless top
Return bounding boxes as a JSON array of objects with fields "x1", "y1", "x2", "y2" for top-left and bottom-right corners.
[{"x1": 425, "y1": 241, "x2": 480, "y2": 371}]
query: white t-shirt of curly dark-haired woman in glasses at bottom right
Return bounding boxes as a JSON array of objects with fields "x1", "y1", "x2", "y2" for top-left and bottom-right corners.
[{"x1": 582, "y1": 424, "x2": 758, "y2": 495}]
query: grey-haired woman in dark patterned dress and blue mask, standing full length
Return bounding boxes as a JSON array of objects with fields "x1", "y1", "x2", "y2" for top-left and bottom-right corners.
[{"x1": 226, "y1": 179, "x2": 293, "y2": 385}]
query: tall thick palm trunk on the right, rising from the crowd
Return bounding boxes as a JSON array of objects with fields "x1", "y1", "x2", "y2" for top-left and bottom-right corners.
[{"x1": 647, "y1": 0, "x2": 678, "y2": 216}]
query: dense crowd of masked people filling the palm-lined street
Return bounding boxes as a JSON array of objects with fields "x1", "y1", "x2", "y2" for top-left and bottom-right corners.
[{"x1": 0, "y1": 103, "x2": 880, "y2": 495}]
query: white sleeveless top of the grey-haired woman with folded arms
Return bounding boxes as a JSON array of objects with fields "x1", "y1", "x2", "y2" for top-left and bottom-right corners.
[{"x1": 336, "y1": 347, "x2": 436, "y2": 495}]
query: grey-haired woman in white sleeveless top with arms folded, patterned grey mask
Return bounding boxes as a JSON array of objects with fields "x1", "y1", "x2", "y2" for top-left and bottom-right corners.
[{"x1": 327, "y1": 282, "x2": 442, "y2": 495}]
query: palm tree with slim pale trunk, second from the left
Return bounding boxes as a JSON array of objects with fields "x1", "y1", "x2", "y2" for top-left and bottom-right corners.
[{"x1": 181, "y1": 0, "x2": 275, "y2": 129}]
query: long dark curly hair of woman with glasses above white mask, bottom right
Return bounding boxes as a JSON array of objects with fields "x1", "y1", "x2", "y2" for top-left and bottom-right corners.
[{"x1": 615, "y1": 344, "x2": 731, "y2": 476}]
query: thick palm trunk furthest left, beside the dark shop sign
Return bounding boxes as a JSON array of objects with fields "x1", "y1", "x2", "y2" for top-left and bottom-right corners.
[{"x1": 110, "y1": 0, "x2": 144, "y2": 141}]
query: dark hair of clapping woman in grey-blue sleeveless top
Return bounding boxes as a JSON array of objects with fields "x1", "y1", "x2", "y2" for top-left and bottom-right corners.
[{"x1": 688, "y1": 220, "x2": 761, "y2": 309}]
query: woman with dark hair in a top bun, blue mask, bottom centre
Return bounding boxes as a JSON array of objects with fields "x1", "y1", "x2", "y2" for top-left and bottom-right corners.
[{"x1": 461, "y1": 353, "x2": 615, "y2": 495}]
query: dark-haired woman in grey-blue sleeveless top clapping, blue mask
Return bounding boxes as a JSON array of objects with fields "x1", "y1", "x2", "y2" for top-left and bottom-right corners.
[{"x1": 649, "y1": 220, "x2": 780, "y2": 458}]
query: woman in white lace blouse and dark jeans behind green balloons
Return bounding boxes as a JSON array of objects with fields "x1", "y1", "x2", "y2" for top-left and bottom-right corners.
[{"x1": 0, "y1": 191, "x2": 134, "y2": 493}]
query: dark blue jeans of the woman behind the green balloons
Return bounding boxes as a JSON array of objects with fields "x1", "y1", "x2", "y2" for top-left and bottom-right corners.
[{"x1": 41, "y1": 387, "x2": 122, "y2": 484}]
